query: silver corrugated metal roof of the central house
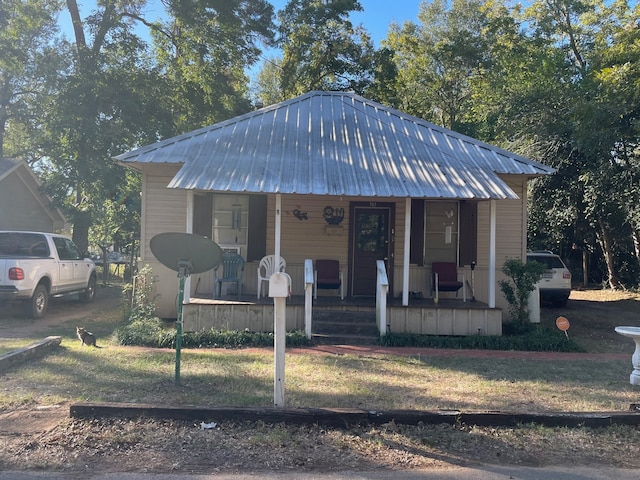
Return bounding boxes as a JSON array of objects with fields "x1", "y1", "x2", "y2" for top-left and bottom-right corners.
[{"x1": 116, "y1": 91, "x2": 554, "y2": 199}]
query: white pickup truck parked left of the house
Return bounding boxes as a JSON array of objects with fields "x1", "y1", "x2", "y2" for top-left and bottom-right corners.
[{"x1": 0, "y1": 231, "x2": 96, "y2": 318}]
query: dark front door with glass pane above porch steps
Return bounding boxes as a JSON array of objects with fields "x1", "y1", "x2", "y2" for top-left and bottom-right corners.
[{"x1": 349, "y1": 202, "x2": 395, "y2": 296}]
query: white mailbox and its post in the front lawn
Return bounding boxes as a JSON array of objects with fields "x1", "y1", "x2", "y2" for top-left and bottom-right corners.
[{"x1": 269, "y1": 272, "x2": 291, "y2": 408}]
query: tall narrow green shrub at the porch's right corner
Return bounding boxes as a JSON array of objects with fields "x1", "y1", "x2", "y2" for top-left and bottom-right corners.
[{"x1": 498, "y1": 258, "x2": 546, "y2": 332}]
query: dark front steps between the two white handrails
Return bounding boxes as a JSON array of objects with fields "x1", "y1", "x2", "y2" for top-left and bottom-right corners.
[{"x1": 311, "y1": 310, "x2": 379, "y2": 345}]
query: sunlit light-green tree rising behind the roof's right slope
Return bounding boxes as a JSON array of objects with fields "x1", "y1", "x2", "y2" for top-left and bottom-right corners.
[{"x1": 384, "y1": 0, "x2": 489, "y2": 131}]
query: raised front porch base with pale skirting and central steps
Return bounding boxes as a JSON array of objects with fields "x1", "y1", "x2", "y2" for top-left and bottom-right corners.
[{"x1": 183, "y1": 295, "x2": 502, "y2": 343}]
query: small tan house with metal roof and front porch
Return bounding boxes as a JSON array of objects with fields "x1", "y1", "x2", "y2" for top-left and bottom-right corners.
[{"x1": 116, "y1": 91, "x2": 554, "y2": 334}]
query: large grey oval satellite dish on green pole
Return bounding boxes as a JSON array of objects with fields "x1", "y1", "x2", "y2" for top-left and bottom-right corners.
[{"x1": 150, "y1": 232, "x2": 222, "y2": 273}]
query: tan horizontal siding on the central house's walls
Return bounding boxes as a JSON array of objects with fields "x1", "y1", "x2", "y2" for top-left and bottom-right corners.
[{"x1": 141, "y1": 171, "x2": 526, "y2": 316}]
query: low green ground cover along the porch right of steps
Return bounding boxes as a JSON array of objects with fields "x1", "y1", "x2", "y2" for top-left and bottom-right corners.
[{"x1": 379, "y1": 325, "x2": 584, "y2": 352}]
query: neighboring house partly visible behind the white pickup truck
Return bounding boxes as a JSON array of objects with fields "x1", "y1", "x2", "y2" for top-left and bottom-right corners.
[{"x1": 0, "y1": 158, "x2": 65, "y2": 232}]
